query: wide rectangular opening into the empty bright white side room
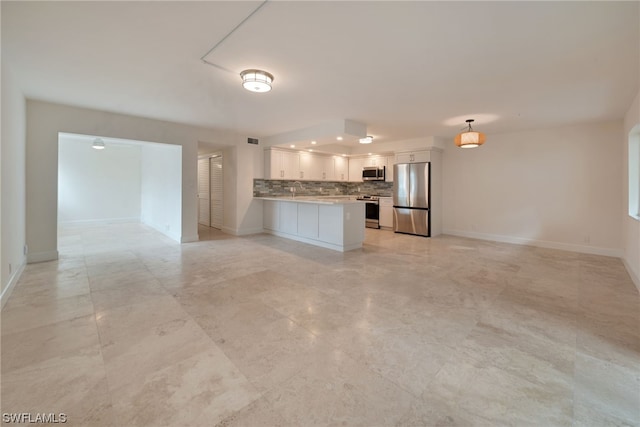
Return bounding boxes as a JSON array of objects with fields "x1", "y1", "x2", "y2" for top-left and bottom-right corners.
[{"x1": 57, "y1": 132, "x2": 182, "y2": 242}]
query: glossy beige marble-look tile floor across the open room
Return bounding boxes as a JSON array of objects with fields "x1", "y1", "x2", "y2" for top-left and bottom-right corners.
[{"x1": 1, "y1": 224, "x2": 640, "y2": 427}]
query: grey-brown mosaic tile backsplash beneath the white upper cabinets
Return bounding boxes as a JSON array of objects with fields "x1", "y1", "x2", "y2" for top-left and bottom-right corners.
[{"x1": 253, "y1": 179, "x2": 393, "y2": 197}]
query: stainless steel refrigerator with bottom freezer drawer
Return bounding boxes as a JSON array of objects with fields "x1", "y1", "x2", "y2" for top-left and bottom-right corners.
[{"x1": 393, "y1": 163, "x2": 431, "y2": 237}]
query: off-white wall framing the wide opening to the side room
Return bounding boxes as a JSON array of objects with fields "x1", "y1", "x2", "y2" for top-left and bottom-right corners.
[{"x1": 26, "y1": 100, "x2": 245, "y2": 262}]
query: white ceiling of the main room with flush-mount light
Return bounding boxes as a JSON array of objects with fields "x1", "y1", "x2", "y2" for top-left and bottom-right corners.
[{"x1": 1, "y1": 1, "x2": 640, "y2": 152}]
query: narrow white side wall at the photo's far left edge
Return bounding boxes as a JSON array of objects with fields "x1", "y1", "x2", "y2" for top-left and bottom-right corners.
[{"x1": 0, "y1": 61, "x2": 26, "y2": 305}]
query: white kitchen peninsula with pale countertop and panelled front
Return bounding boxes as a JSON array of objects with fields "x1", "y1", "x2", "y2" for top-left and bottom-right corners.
[{"x1": 254, "y1": 196, "x2": 365, "y2": 252}]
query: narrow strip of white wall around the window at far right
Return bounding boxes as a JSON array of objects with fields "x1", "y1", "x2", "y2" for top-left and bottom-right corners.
[{"x1": 621, "y1": 91, "x2": 640, "y2": 291}]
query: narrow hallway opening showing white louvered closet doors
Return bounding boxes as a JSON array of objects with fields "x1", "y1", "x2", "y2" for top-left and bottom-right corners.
[{"x1": 198, "y1": 154, "x2": 224, "y2": 230}]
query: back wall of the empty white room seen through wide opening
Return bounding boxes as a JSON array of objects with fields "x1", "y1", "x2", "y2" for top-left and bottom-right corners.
[{"x1": 58, "y1": 135, "x2": 141, "y2": 223}]
